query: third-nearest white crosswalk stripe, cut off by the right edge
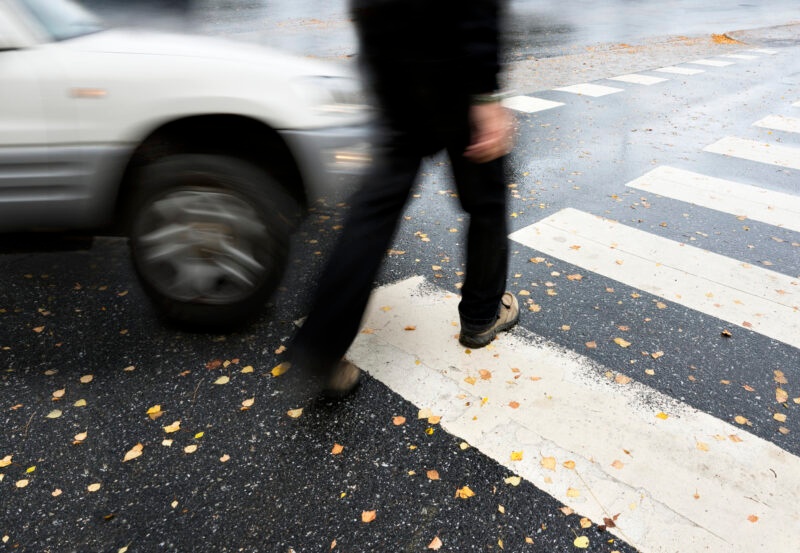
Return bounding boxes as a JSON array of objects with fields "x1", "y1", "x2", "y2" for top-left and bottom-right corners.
[{"x1": 627, "y1": 166, "x2": 800, "y2": 232}]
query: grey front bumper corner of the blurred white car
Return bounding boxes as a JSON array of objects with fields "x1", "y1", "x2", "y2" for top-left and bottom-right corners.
[{"x1": 281, "y1": 125, "x2": 374, "y2": 202}]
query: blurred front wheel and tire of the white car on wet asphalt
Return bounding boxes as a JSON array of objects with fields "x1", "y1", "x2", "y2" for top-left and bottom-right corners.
[{"x1": 130, "y1": 154, "x2": 297, "y2": 329}]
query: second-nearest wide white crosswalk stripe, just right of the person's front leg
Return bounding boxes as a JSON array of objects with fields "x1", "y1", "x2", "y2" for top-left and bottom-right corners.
[{"x1": 510, "y1": 209, "x2": 800, "y2": 347}]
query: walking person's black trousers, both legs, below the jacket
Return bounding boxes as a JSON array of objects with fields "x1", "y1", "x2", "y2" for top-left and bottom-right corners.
[{"x1": 290, "y1": 116, "x2": 508, "y2": 378}]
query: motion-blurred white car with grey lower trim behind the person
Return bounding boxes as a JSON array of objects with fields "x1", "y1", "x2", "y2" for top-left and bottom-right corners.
[{"x1": 0, "y1": 0, "x2": 370, "y2": 325}]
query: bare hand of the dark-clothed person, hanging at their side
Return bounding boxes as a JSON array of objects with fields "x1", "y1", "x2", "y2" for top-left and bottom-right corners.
[{"x1": 464, "y1": 102, "x2": 514, "y2": 163}]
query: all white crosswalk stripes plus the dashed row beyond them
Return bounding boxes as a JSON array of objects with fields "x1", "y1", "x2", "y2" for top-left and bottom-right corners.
[{"x1": 348, "y1": 44, "x2": 800, "y2": 553}]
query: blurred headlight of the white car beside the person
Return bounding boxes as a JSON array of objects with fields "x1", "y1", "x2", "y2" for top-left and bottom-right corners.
[{"x1": 294, "y1": 76, "x2": 370, "y2": 114}]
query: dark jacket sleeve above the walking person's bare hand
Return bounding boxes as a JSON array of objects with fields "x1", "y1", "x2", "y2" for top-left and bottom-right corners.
[{"x1": 458, "y1": 0, "x2": 504, "y2": 95}]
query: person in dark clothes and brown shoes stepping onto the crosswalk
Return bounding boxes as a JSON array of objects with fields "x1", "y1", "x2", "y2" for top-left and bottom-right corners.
[{"x1": 289, "y1": 0, "x2": 519, "y2": 396}]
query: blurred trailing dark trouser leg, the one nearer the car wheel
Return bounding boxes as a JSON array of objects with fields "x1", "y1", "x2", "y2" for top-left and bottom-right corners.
[{"x1": 289, "y1": 142, "x2": 421, "y2": 386}]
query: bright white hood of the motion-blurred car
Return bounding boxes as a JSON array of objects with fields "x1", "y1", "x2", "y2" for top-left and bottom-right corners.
[{"x1": 72, "y1": 29, "x2": 352, "y2": 76}]
